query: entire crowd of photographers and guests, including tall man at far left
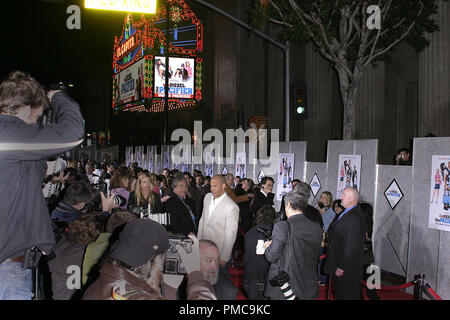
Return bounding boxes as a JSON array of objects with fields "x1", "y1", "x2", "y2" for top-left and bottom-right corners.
[{"x1": 0, "y1": 72, "x2": 377, "y2": 300}]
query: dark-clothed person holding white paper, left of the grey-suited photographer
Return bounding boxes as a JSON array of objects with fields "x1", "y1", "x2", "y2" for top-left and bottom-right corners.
[{"x1": 244, "y1": 205, "x2": 275, "y2": 300}]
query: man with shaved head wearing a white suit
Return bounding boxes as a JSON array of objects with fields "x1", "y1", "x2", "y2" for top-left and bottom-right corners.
[{"x1": 197, "y1": 175, "x2": 239, "y2": 298}]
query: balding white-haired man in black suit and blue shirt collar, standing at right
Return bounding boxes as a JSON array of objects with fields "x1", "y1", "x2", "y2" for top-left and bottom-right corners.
[{"x1": 324, "y1": 188, "x2": 367, "y2": 300}]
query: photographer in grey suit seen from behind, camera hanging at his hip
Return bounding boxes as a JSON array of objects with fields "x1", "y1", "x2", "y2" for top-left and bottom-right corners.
[{"x1": 264, "y1": 189, "x2": 322, "y2": 300}]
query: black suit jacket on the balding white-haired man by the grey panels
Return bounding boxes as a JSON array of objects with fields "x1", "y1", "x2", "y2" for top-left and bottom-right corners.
[{"x1": 324, "y1": 206, "x2": 367, "y2": 276}]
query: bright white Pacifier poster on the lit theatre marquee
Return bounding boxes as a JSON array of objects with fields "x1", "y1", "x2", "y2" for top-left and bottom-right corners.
[{"x1": 154, "y1": 57, "x2": 195, "y2": 99}]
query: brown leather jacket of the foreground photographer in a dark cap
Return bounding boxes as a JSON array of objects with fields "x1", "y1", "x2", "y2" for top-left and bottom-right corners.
[{"x1": 83, "y1": 262, "x2": 217, "y2": 300}]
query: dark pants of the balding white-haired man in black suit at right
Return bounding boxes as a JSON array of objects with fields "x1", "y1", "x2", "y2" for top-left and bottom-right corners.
[{"x1": 332, "y1": 270, "x2": 362, "y2": 300}]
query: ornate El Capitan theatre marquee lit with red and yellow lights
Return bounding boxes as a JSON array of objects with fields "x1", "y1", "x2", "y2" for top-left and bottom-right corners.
[{"x1": 111, "y1": 0, "x2": 203, "y2": 112}]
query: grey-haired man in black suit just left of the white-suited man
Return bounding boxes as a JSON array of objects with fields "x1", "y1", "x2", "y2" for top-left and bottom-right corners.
[{"x1": 164, "y1": 173, "x2": 198, "y2": 236}]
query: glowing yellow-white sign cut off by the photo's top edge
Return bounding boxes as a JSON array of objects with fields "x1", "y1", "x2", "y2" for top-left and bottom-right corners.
[{"x1": 84, "y1": 0, "x2": 156, "y2": 13}]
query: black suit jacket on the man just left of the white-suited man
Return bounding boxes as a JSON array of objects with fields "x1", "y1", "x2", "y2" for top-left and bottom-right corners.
[{"x1": 164, "y1": 192, "x2": 198, "y2": 236}]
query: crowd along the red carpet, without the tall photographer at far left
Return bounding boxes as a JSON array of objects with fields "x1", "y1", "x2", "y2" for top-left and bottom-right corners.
[{"x1": 6, "y1": 154, "x2": 377, "y2": 300}]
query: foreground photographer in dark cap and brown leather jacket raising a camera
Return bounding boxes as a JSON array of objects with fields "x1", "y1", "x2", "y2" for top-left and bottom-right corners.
[{"x1": 83, "y1": 219, "x2": 216, "y2": 300}]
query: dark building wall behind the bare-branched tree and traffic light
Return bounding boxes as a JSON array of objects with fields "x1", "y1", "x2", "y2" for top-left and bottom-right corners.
[{"x1": 208, "y1": 0, "x2": 450, "y2": 164}]
